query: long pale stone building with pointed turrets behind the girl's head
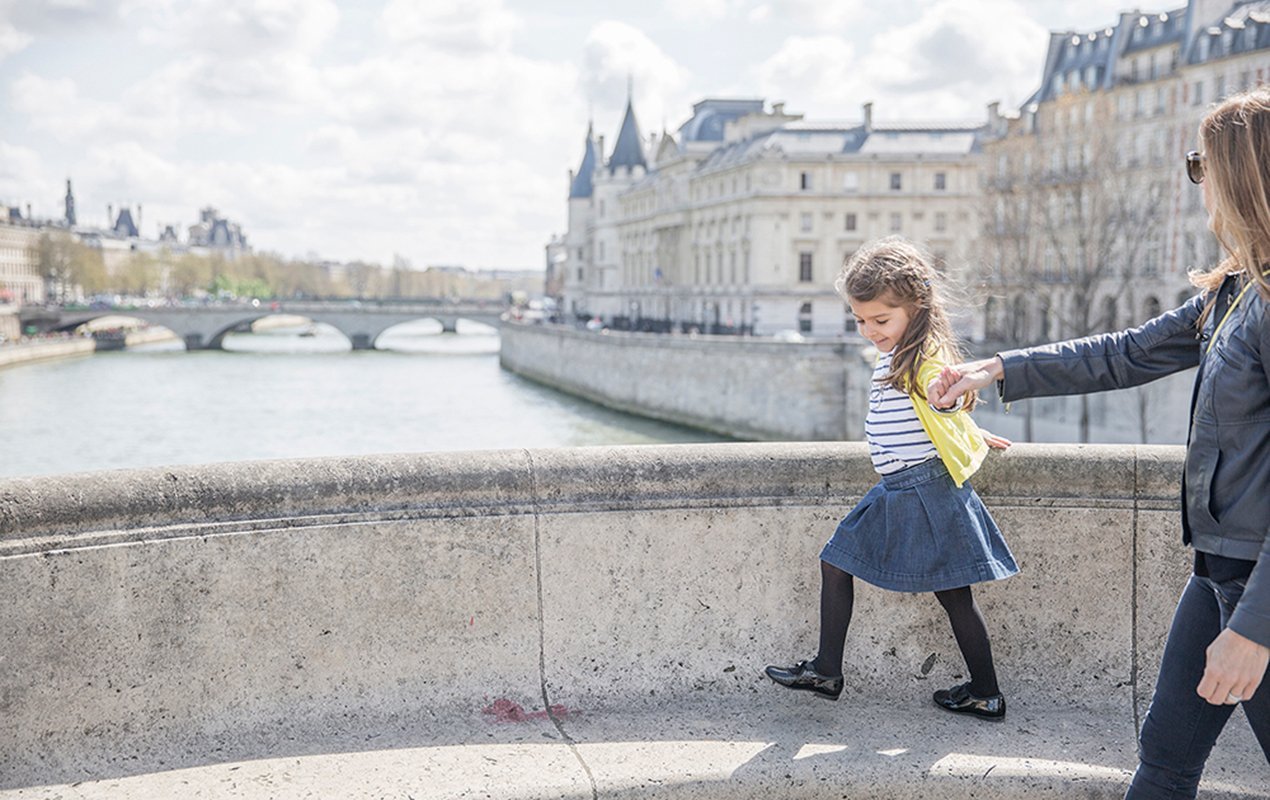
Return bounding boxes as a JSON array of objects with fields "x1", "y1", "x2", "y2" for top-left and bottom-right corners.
[{"x1": 559, "y1": 99, "x2": 984, "y2": 337}]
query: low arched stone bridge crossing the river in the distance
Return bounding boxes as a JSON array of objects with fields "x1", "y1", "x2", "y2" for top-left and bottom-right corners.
[{"x1": 19, "y1": 301, "x2": 507, "y2": 350}]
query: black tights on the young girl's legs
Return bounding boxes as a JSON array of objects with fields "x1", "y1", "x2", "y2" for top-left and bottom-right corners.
[{"x1": 815, "y1": 561, "x2": 999, "y2": 697}]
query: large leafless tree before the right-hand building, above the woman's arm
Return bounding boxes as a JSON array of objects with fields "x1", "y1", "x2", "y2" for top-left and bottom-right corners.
[{"x1": 980, "y1": 91, "x2": 1167, "y2": 442}]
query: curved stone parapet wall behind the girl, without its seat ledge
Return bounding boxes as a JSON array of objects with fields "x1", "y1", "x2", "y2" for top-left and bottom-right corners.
[{"x1": 0, "y1": 443, "x2": 1260, "y2": 796}]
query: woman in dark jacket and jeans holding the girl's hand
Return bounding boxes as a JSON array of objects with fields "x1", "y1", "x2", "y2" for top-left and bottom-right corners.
[{"x1": 928, "y1": 86, "x2": 1270, "y2": 800}]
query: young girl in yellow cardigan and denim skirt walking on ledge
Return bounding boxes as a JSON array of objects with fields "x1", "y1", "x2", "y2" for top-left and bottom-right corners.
[{"x1": 766, "y1": 236, "x2": 1019, "y2": 720}]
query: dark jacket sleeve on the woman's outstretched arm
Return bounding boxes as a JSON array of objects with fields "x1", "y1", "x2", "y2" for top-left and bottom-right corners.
[{"x1": 997, "y1": 295, "x2": 1205, "y2": 403}]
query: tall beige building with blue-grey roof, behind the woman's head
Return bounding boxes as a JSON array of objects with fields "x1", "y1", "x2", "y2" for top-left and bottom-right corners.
[{"x1": 982, "y1": 0, "x2": 1270, "y2": 342}]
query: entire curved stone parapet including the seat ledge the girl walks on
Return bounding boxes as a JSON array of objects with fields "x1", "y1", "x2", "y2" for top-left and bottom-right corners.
[{"x1": 0, "y1": 444, "x2": 1270, "y2": 797}]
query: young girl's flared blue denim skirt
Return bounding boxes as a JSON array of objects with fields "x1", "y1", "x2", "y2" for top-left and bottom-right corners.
[{"x1": 820, "y1": 458, "x2": 1019, "y2": 592}]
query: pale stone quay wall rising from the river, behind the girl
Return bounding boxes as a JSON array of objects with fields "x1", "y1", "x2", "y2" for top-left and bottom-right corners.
[{"x1": 500, "y1": 325, "x2": 1194, "y2": 444}]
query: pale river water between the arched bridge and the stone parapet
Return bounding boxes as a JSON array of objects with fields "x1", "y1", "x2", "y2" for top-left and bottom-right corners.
[{"x1": 0, "y1": 323, "x2": 720, "y2": 476}]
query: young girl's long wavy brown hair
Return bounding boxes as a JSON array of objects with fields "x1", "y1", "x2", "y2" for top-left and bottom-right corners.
[{"x1": 833, "y1": 236, "x2": 978, "y2": 410}]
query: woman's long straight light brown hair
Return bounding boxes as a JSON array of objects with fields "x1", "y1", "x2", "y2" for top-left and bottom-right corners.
[{"x1": 1190, "y1": 86, "x2": 1270, "y2": 326}]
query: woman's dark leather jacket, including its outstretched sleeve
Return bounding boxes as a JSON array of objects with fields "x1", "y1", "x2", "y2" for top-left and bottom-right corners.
[{"x1": 999, "y1": 277, "x2": 1270, "y2": 646}]
